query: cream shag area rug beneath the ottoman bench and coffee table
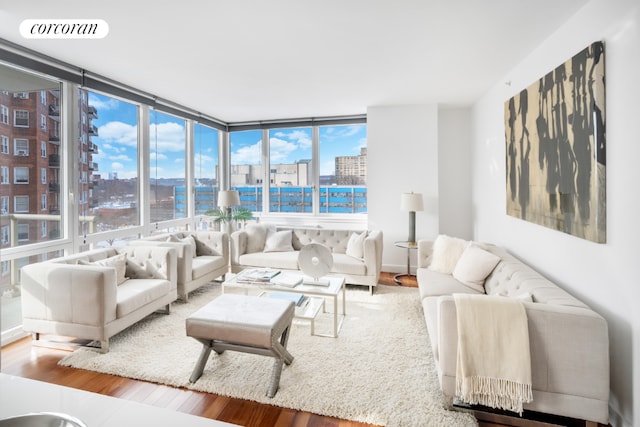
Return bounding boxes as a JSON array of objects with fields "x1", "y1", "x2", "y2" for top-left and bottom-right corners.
[{"x1": 59, "y1": 283, "x2": 477, "y2": 427}]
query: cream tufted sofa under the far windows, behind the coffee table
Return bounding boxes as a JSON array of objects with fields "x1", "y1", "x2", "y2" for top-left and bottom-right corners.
[{"x1": 231, "y1": 224, "x2": 382, "y2": 292}]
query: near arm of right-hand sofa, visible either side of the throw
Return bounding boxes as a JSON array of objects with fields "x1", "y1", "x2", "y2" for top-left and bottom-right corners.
[{"x1": 437, "y1": 296, "x2": 609, "y2": 402}]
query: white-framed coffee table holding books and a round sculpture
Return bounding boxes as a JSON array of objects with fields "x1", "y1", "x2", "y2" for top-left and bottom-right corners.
[{"x1": 222, "y1": 272, "x2": 347, "y2": 338}]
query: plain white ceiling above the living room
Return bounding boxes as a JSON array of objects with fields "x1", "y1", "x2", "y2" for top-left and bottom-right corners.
[{"x1": 0, "y1": 0, "x2": 588, "y2": 122}]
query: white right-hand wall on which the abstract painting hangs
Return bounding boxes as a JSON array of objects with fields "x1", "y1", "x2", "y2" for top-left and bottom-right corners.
[{"x1": 472, "y1": 0, "x2": 640, "y2": 427}]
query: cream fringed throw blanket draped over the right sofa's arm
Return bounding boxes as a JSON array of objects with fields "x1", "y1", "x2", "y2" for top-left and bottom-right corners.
[{"x1": 454, "y1": 294, "x2": 533, "y2": 415}]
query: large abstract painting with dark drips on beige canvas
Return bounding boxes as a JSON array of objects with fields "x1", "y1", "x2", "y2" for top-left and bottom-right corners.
[{"x1": 504, "y1": 42, "x2": 606, "y2": 243}]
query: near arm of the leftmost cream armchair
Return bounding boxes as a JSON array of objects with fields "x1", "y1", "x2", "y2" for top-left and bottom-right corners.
[{"x1": 20, "y1": 262, "x2": 117, "y2": 326}]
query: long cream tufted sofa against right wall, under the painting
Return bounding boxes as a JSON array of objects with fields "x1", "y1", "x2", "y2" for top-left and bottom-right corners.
[{"x1": 417, "y1": 236, "x2": 609, "y2": 426}]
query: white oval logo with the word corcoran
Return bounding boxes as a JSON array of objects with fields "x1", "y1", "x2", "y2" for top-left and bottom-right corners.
[{"x1": 20, "y1": 19, "x2": 109, "y2": 39}]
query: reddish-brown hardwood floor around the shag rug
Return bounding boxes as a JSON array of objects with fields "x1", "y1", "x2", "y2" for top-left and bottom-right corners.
[{"x1": 0, "y1": 273, "x2": 600, "y2": 427}]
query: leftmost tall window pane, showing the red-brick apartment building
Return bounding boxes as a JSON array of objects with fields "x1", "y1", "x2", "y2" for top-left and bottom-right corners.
[{"x1": 0, "y1": 64, "x2": 67, "y2": 340}]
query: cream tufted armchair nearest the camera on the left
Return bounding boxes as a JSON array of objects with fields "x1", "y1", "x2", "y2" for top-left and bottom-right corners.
[{"x1": 20, "y1": 246, "x2": 177, "y2": 352}]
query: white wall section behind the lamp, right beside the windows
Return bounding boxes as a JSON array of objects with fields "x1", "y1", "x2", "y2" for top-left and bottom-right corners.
[{"x1": 367, "y1": 105, "x2": 438, "y2": 272}]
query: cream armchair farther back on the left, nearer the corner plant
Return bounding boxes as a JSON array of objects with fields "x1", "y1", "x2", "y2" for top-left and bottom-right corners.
[{"x1": 129, "y1": 231, "x2": 229, "y2": 302}]
